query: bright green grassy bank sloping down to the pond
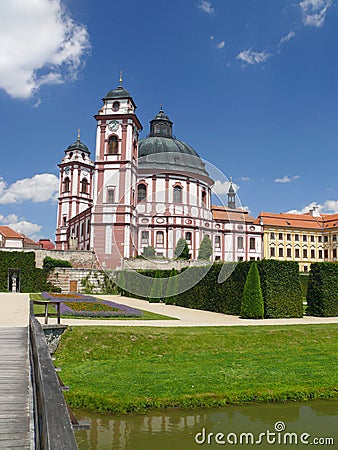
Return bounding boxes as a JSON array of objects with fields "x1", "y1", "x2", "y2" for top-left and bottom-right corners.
[{"x1": 56, "y1": 324, "x2": 338, "y2": 412}]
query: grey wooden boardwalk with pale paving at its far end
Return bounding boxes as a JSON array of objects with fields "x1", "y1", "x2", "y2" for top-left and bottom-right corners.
[{"x1": 0, "y1": 294, "x2": 31, "y2": 450}]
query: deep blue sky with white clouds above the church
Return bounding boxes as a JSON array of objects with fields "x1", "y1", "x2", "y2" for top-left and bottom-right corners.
[{"x1": 0, "y1": 0, "x2": 338, "y2": 239}]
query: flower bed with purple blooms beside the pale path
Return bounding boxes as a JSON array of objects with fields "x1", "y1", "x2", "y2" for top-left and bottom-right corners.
[{"x1": 42, "y1": 292, "x2": 142, "y2": 318}]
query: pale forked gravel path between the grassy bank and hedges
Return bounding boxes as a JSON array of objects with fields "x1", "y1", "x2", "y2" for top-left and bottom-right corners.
[{"x1": 40, "y1": 295, "x2": 338, "y2": 327}]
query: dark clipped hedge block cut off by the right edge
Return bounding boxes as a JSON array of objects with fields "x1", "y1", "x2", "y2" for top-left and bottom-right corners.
[{"x1": 306, "y1": 262, "x2": 338, "y2": 317}]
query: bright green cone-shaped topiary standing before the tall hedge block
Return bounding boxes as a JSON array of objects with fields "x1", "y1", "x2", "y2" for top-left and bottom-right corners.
[{"x1": 241, "y1": 261, "x2": 264, "y2": 319}]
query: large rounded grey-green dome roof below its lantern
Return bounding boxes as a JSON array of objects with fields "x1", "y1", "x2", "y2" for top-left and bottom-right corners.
[{"x1": 138, "y1": 136, "x2": 209, "y2": 178}]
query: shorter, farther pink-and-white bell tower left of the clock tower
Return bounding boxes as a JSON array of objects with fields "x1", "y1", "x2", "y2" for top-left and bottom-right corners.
[{"x1": 55, "y1": 130, "x2": 94, "y2": 250}]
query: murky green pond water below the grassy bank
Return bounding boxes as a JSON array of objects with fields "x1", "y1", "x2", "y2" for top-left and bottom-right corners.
[{"x1": 76, "y1": 400, "x2": 338, "y2": 450}]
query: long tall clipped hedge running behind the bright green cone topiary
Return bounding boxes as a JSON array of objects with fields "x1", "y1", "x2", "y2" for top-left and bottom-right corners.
[{"x1": 120, "y1": 260, "x2": 303, "y2": 318}]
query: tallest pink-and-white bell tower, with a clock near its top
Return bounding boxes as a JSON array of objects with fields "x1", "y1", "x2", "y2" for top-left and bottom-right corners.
[{"x1": 91, "y1": 74, "x2": 142, "y2": 269}]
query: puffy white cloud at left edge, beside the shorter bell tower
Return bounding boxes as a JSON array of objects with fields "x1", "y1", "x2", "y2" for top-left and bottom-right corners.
[{"x1": 0, "y1": 173, "x2": 59, "y2": 205}]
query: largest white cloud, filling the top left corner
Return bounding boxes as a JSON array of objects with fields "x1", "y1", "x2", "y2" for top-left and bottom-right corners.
[{"x1": 0, "y1": 0, "x2": 90, "y2": 98}]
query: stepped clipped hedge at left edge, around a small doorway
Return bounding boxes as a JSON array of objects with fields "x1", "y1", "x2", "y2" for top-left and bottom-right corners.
[{"x1": 0, "y1": 251, "x2": 52, "y2": 292}]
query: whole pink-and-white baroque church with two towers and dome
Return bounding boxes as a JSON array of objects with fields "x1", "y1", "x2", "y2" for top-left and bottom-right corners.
[{"x1": 56, "y1": 79, "x2": 263, "y2": 269}]
